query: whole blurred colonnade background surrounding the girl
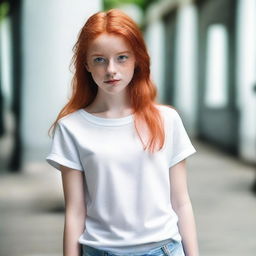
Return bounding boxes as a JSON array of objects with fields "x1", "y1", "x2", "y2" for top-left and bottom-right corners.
[{"x1": 0, "y1": 0, "x2": 256, "y2": 256}]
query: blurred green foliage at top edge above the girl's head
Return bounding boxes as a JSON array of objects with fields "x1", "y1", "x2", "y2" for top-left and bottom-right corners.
[{"x1": 103, "y1": 0, "x2": 160, "y2": 11}]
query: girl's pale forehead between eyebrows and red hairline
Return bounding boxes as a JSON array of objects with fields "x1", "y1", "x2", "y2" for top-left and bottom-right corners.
[{"x1": 88, "y1": 34, "x2": 132, "y2": 55}]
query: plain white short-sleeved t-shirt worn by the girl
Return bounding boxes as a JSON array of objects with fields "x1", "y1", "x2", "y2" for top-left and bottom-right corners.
[{"x1": 46, "y1": 105, "x2": 196, "y2": 253}]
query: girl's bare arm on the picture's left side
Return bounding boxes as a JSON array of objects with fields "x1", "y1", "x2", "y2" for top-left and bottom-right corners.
[{"x1": 61, "y1": 166, "x2": 86, "y2": 256}]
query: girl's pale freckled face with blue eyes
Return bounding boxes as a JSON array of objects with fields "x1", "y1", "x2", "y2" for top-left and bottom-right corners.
[{"x1": 86, "y1": 34, "x2": 135, "y2": 94}]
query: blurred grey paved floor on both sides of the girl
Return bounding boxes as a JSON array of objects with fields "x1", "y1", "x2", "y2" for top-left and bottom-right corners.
[{"x1": 0, "y1": 139, "x2": 256, "y2": 256}]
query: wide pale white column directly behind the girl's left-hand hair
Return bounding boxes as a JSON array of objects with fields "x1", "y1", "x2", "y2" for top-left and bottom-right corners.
[{"x1": 22, "y1": 0, "x2": 102, "y2": 162}]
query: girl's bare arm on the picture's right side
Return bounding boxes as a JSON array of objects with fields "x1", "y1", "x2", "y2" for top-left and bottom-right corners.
[{"x1": 169, "y1": 159, "x2": 199, "y2": 256}]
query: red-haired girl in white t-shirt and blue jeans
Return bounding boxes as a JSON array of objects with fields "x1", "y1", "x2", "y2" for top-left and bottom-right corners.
[{"x1": 46, "y1": 9, "x2": 198, "y2": 256}]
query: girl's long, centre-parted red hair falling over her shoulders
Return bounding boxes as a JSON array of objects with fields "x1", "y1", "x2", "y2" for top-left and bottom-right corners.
[{"x1": 50, "y1": 9, "x2": 174, "y2": 153}]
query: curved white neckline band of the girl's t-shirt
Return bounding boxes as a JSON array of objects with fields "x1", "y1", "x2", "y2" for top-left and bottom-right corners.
[{"x1": 79, "y1": 108, "x2": 134, "y2": 126}]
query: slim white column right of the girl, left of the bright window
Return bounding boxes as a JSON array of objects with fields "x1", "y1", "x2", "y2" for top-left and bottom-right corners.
[{"x1": 175, "y1": 4, "x2": 197, "y2": 134}]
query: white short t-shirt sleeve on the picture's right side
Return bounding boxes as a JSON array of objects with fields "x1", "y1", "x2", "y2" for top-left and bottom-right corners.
[{"x1": 169, "y1": 110, "x2": 196, "y2": 168}]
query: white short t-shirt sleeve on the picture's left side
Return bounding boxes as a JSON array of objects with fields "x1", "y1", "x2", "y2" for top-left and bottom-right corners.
[{"x1": 46, "y1": 122, "x2": 83, "y2": 171}]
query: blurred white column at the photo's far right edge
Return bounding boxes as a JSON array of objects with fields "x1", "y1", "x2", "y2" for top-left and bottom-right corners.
[{"x1": 236, "y1": 0, "x2": 256, "y2": 162}]
